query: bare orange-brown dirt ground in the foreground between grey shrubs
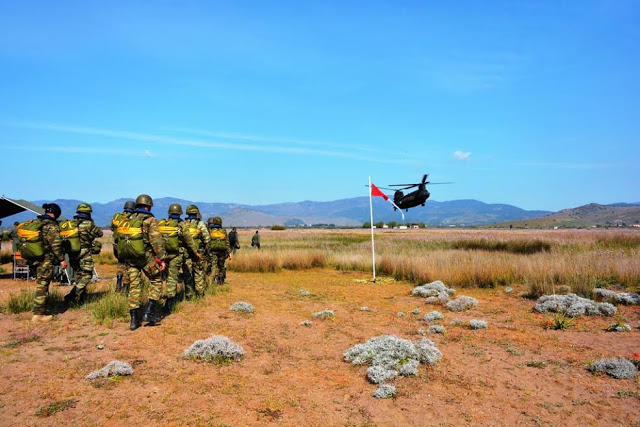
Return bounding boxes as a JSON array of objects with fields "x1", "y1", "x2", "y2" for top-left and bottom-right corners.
[{"x1": 0, "y1": 267, "x2": 640, "y2": 426}]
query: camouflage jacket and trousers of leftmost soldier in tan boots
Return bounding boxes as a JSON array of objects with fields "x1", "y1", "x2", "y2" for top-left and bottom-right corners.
[{"x1": 29, "y1": 215, "x2": 64, "y2": 315}]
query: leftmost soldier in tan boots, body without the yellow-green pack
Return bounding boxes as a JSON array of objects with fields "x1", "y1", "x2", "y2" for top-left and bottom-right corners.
[{"x1": 29, "y1": 203, "x2": 67, "y2": 322}]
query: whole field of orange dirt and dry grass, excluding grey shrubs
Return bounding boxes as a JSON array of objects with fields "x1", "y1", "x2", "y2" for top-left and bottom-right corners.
[{"x1": 0, "y1": 230, "x2": 640, "y2": 426}]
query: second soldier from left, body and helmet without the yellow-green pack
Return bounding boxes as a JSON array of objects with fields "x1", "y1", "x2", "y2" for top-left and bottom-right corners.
[{"x1": 64, "y1": 203, "x2": 102, "y2": 304}]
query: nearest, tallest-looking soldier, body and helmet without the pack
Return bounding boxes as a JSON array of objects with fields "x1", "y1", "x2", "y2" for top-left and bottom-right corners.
[{"x1": 126, "y1": 194, "x2": 166, "y2": 331}]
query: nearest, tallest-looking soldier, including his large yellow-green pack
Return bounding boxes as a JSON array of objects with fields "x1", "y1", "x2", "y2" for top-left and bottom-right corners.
[{"x1": 118, "y1": 194, "x2": 166, "y2": 331}]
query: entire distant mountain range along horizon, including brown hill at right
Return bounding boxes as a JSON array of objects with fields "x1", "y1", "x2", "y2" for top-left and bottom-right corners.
[{"x1": 4, "y1": 197, "x2": 640, "y2": 231}]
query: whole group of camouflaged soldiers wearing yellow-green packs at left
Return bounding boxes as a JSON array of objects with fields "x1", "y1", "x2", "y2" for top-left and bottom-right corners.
[{"x1": 17, "y1": 194, "x2": 232, "y2": 331}]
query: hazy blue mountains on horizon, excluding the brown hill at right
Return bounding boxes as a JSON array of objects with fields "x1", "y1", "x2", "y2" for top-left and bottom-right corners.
[{"x1": 5, "y1": 197, "x2": 551, "y2": 227}]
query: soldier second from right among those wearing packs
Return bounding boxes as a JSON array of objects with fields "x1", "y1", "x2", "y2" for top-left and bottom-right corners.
[{"x1": 184, "y1": 205, "x2": 209, "y2": 298}]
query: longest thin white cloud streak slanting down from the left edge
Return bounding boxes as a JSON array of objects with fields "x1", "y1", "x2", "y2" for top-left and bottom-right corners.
[{"x1": 2, "y1": 122, "x2": 413, "y2": 164}]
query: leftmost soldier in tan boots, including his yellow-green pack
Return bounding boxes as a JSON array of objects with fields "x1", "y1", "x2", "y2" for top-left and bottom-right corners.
[{"x1": 18, "y1": 203, "x2": 67, "y2": 322}]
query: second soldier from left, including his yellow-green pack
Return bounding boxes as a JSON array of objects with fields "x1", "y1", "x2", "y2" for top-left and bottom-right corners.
[{"x1": 60, "y1": 203, "x2": 102, "y2": 304}]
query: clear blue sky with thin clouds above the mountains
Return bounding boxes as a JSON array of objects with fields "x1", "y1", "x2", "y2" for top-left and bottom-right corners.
[{"x1": 0, "y1": 0, "x2": 640, "y2": 210}]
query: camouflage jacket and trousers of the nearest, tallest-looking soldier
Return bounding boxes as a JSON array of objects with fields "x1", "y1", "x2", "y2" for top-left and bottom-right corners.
[{"x1": 126, "y1": 209, "x2": 166, "y2": 310}]
